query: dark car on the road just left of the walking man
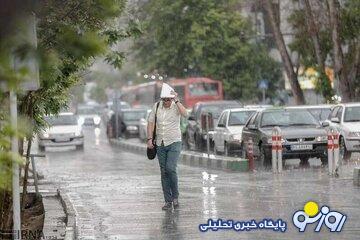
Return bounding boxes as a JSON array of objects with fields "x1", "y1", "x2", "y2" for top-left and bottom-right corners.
[{"x1": 107, "y1": 108, "x2": 147, "y2": 138}]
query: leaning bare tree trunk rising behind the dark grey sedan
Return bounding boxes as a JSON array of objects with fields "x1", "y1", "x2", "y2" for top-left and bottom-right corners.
[{"x1": 263, "y1": 0, "x2": 305, "y2": 105}]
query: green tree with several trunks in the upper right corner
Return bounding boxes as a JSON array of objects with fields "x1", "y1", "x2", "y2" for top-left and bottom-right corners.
[{"x1": 289, "y1": 0, "x2": 360, "y2": 101}]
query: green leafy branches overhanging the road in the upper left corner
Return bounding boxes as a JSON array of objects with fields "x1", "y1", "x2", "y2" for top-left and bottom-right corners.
[{"x1": 0, "y1": 0, "x2": 138, "y2": 229}]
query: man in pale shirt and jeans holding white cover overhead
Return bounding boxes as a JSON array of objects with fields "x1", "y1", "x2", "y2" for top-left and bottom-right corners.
[{"x1": 147, "y1": 83, "x2": 187, "y2": 210}]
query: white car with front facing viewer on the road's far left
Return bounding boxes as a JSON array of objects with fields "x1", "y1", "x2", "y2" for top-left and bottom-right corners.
[{"x1": 38, "y1": 113, "x2": 84, "y2": 151}]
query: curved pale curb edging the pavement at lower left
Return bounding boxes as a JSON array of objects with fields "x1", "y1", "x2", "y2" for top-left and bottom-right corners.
[{"x1": 57, "y1": 189, "x2": 77, "y2": 240}]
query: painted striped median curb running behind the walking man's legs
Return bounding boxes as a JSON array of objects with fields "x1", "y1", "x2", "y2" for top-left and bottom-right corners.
[{"x1": 109, "y1": 139, "x2": 249, "y2": 172}]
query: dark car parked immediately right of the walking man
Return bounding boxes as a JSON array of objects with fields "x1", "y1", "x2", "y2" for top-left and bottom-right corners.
[{"x1": 185, "y1": 101, "x2": 242, "y2": 151}]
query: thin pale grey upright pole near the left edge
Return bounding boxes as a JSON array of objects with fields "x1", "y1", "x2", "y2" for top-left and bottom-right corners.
[{"x1": 10, "y1": 90, "x2": 21, "y2": 240}]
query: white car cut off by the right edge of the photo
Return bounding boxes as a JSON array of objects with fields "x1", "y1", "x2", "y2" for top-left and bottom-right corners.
[{"x1": 328, "y1": 103, "x2": 360, "y2": 160}]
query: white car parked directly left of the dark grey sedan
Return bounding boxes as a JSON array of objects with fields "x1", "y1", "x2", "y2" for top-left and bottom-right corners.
[{"x1": 213, "y1": 108, "x2": 259, "y2": 156}]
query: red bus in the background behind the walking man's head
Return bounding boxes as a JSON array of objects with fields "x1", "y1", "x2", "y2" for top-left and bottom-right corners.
[{"x1": 121, "y1": 77, "x2": 224, "y2": 108}]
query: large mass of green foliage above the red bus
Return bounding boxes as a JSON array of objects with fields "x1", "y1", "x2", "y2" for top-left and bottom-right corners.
[{"x1": 135, "y1": 0, "x2": 281, "y2": 101}]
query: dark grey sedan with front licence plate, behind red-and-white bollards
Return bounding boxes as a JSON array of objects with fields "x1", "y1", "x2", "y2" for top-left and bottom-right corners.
[{"x1": 242, "y1": 108, "x2": 329, "y2": 166}]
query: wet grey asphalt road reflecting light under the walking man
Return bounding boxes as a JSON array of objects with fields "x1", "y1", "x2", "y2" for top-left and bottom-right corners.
[{"x1": 38, "y1": 128, "x2": 360, "y2": 239}]
